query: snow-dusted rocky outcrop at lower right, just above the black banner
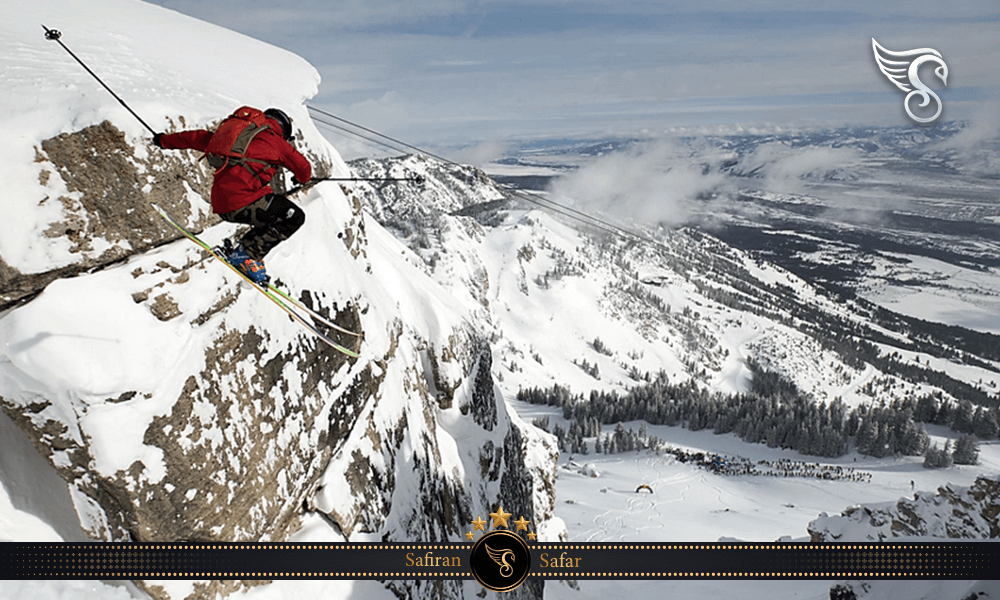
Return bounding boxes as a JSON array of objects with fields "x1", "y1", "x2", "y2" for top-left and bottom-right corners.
[{"x1": 808, "y1": 477, "x2": 1000, "y2": 543}]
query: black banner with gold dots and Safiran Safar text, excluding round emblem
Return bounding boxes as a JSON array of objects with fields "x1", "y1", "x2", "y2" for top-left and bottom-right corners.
[{"x1": 0, "y1": 542, "x2": 1000, "y2": 580}]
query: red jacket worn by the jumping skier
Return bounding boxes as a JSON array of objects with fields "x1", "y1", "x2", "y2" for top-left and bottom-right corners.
[{"x1": 160, "y1": 119, "x2": 312, "y2": 214}]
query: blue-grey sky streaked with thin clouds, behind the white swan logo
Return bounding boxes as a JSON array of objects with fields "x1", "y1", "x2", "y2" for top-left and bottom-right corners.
[{"x1": 143, "y1": 0, "x2": 1000, "y2": 145}]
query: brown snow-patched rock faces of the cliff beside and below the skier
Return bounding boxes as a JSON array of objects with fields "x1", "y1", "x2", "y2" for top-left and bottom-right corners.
[{"x1": 0, "y1": 116, "x2": 365, "y2": 541}]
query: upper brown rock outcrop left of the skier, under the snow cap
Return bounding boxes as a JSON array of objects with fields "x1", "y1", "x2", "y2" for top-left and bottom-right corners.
[{"x1": 0, "y1": 121, "x2": 218, "y2": 310}]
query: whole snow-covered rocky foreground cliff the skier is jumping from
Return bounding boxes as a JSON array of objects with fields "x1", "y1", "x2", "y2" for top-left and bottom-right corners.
[{"x1": 0, "y1": 0, "x2": 564, "y2": 598}]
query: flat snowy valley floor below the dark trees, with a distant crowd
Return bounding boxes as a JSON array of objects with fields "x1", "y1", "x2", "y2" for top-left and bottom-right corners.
[{"x1": 512, "y1": 401, "x2": 1000, "y2": 542}]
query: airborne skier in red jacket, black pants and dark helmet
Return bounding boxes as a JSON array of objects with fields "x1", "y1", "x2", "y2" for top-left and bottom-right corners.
[{"x1": 153, "y1": 106, "x2": 312, "y2": 285}]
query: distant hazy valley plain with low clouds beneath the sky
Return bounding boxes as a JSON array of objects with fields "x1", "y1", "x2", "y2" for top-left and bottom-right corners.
[{"x1": 487, "y1": 123, "x2": 1000, "y2": 336}]
